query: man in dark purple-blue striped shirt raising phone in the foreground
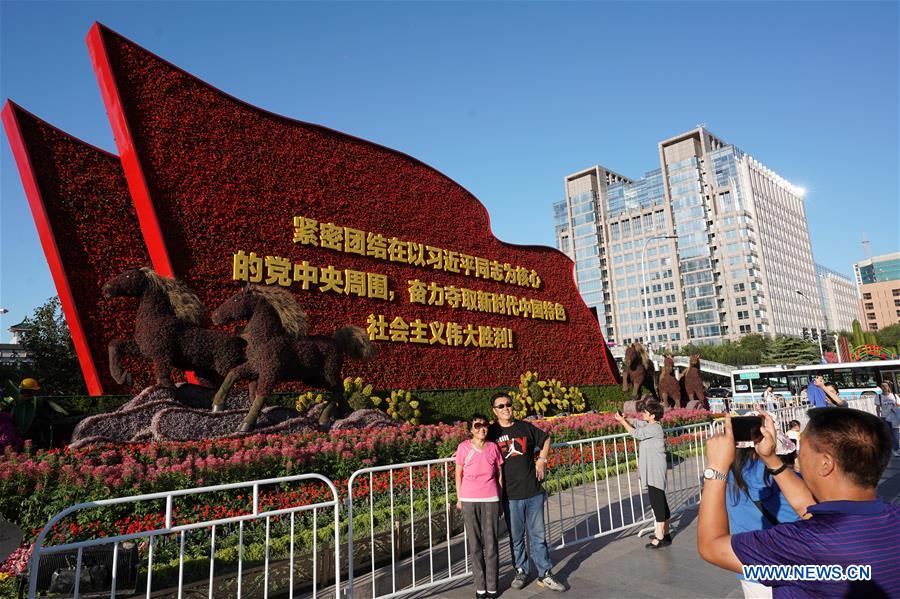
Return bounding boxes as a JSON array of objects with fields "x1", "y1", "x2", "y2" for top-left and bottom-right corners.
[{"x1": 697, "y1": 409, "x2": 900, "y2": 597}]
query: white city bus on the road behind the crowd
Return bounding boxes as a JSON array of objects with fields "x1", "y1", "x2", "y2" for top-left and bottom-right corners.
[{"x1": 731, "y1": 360, "x2": 900, "y2": 408}]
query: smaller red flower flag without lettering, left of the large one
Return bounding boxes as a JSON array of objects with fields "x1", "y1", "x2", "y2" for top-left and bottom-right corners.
[{"x1": 3, "y1": 102, "x2": 149, "y2": 395}]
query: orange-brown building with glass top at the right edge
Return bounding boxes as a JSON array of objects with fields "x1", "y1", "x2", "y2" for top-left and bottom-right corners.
[{"x1": 853, "y1": 252, "x2": 900, "y2": 331}]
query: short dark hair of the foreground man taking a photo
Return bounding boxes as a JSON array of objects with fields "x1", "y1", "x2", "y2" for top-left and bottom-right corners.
[{"x1": 803, "y1": 408, "x2": 891, "y2": 489}]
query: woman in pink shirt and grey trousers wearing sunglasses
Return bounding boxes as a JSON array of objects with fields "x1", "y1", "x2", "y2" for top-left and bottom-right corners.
[{"x1": 456, "y1": 414, "x2": 503, "y2": 599}]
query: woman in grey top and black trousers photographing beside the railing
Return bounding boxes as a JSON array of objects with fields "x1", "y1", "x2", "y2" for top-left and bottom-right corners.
[{"x1": 616, "y1": 399, "x2": 672, "y2": 549}]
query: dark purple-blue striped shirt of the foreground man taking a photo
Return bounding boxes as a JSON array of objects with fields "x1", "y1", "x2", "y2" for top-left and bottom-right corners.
[{"x1": 731, "y1": 499, "x2": 900, "y2": 598}]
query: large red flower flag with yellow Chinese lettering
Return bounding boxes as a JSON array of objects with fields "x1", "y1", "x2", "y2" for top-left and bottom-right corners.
[{"x1": 5, "y1": 24, "x2": 616, "y2": 393}]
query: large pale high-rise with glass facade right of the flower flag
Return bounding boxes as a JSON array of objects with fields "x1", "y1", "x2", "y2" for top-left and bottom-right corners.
[{"x1": 554, "y1": 127, "x2": 824, "y2": 349}]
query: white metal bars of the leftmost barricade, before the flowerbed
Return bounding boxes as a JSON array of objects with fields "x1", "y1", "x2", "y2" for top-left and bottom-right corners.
[{"x1": 28, "y1": 474, "x2": 340, "y2": 599}]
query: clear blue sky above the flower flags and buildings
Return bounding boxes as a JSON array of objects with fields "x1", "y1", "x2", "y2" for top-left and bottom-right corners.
[{"x1": 0, "y1": 1, "x2": 900, "y2": 328}]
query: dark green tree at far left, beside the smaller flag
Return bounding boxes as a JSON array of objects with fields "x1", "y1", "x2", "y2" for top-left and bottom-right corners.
[{"x1": 22, "y1": 297, "x2": 87, "y2": 395}]
